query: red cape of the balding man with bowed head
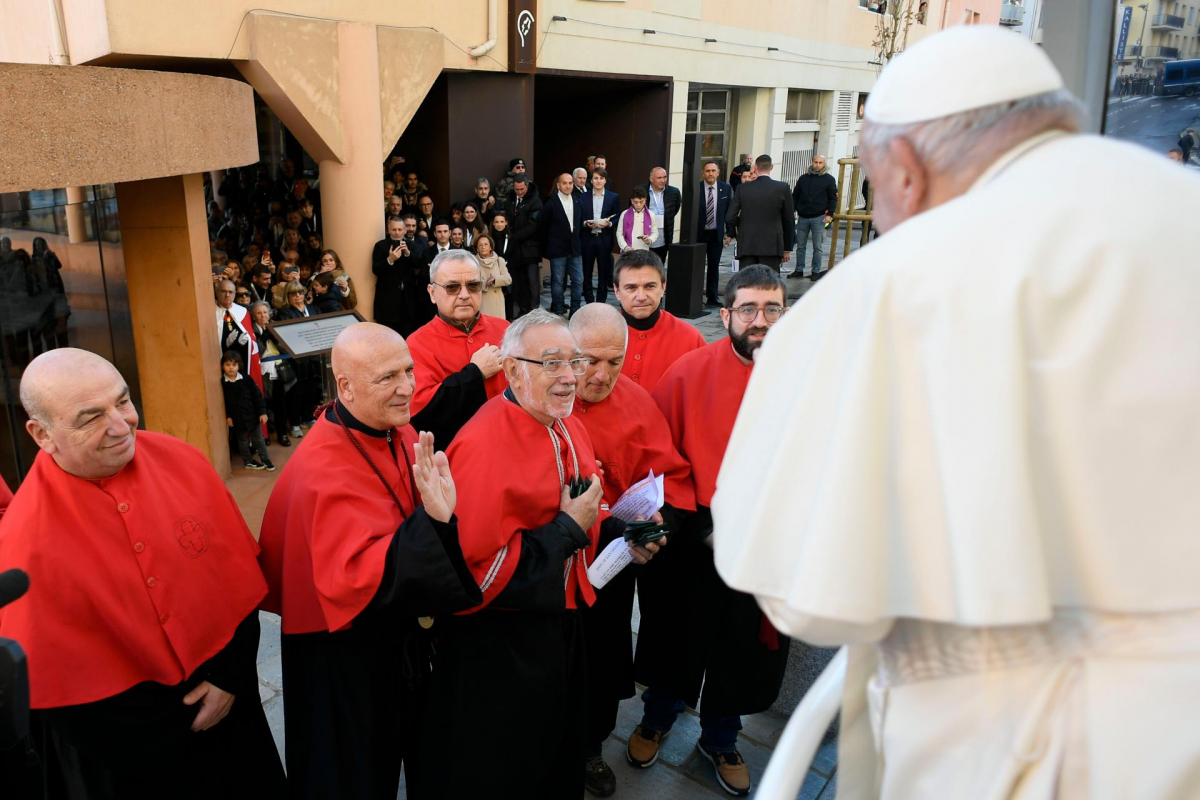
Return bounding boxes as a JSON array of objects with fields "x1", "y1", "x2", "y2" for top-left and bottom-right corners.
[{"x1": 572, "y1": 375, "x2": 696, "y2": 560}]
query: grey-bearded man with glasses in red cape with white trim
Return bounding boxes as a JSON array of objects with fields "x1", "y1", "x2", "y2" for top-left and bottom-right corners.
[{"x1": 422, "y1": 309, "x2": 624, "y2": 800}]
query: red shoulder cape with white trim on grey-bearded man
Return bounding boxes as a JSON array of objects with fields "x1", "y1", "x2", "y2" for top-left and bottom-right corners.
[{"x1": 446, "y1": 395, "x2": 606, "y2": 613}]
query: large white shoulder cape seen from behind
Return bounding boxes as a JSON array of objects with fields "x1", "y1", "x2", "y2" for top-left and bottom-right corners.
[{"x1": 713, "y1": 136, "x2": 1200, "y2": 644}]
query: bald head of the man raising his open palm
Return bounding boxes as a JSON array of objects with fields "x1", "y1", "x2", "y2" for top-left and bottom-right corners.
[{"x1": 330, "y1": 323, "x2": 414, "y2": 431}]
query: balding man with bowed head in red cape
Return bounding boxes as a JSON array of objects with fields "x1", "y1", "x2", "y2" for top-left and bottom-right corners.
[{"x1": 570, "y1": 303, "x2": 696, "y2": 798}]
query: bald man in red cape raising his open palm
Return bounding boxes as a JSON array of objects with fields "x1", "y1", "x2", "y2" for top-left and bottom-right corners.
[{"x1": 260, "y1": 323, "x2": 480, "y2": 800}]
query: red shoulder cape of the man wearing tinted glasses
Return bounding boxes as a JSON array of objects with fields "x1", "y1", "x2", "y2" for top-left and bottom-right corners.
[{"x1": 408, "y1": 314, "x2": 509, "y2": 414}]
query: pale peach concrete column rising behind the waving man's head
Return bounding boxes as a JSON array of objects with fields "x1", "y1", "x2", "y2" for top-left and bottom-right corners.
[{"x1": 319, "y1": 23, "x2": 384, "y2": 319}]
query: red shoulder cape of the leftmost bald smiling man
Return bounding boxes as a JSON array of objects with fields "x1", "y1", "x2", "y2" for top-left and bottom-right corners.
[{"x1": 0, "y1": 431, "x2": 266, "y2": 709}]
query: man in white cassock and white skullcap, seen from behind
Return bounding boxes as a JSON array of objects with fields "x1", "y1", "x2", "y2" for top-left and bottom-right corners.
[{"x1": 713, "y1": 26, "x2": 1200, "y2": 800}]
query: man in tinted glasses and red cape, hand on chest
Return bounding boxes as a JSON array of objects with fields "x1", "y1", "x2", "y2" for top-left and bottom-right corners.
[{"x1": 408, "y1": 249, "x2": 509, "y2": 444}]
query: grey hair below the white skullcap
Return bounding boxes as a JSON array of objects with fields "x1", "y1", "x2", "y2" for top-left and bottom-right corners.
[{"x1": 858, "y1": 89, "x2": 1084, "y2": 174}]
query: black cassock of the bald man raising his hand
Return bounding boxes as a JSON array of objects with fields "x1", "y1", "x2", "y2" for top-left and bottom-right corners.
[{"x1": 282, "y1": 507, "x2": 480, "y2": 800}]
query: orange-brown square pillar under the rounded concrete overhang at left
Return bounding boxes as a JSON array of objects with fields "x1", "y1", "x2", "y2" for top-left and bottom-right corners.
[{"x1": 116, "y1": 173, "x2": 229, "y2": 476}]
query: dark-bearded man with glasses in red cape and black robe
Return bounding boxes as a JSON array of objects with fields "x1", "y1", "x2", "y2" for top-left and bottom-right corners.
[{"x1": 626, "y1": 265, "x2": 788, "y2": 796}]
